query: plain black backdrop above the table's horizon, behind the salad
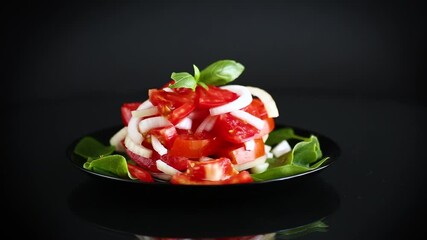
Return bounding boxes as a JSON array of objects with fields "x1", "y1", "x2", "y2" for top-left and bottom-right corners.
[{"x1": 4, "y1": 0, "x2": 425, "y2": 100}]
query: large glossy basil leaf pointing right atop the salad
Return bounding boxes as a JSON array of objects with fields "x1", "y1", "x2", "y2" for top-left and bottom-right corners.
[{"x1": 199, "y1": 60, "x2": 245, "y2": 86}]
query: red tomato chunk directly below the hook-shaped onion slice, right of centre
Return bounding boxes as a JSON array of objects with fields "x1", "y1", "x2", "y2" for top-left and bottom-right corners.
[{"x1": 214, "y1": 113, "x2": 260, "y2": 143}]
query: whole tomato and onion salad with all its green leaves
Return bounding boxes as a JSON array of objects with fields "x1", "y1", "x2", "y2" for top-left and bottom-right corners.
[{"x1": 74, "y1": 60, "x2": 328, "y2": 185}]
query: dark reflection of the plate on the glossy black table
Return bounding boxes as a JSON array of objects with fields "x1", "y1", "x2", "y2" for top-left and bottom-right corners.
[{"x1": 69, "y1": 175, "x2": 339, "y2": 239}]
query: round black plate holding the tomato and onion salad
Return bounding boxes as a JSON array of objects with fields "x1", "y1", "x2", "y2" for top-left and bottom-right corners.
[{"x1": 67, "y1": 125, "x2": 340, "y2": 189}]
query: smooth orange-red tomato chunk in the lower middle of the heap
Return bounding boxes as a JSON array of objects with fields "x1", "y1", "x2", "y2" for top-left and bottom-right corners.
[{"x1": 169, "y1": 133, "x2": 220, "y2": 159}]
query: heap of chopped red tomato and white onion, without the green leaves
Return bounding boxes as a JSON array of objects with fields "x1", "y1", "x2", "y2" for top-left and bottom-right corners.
[{"x1": 121, "y1": 83, "x2": 274, "y2": 184}]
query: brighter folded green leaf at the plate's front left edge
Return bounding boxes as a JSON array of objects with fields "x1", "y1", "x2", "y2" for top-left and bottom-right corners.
[{"x1": 83, "y1": 154, "x2": 129, "y2": 178}]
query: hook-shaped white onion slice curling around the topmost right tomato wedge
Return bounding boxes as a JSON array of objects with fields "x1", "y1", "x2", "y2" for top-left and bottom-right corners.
[{"x1": 209, "y1": 85, "x2": 252, "y2": 115}]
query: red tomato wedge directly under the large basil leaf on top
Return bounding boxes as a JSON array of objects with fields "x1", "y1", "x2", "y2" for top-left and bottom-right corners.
[{"x1": 196, "y1": 85, "x2": 239, "y2": 108}]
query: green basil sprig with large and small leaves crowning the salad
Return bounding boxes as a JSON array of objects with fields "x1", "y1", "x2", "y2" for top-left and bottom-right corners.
[{"x1": 169, "y1": 59, "x2": 245, "y2": 91}]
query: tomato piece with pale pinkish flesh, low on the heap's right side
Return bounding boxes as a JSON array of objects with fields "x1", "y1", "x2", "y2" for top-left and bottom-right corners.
[{"x1": 216, "y1": 138, "x2": 265, "y2": 164}]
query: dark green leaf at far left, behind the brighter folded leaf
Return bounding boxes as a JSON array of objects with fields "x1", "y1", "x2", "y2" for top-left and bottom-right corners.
[{"x1": 74, "y1": 136, "x2": 115, "y2": 159}]
